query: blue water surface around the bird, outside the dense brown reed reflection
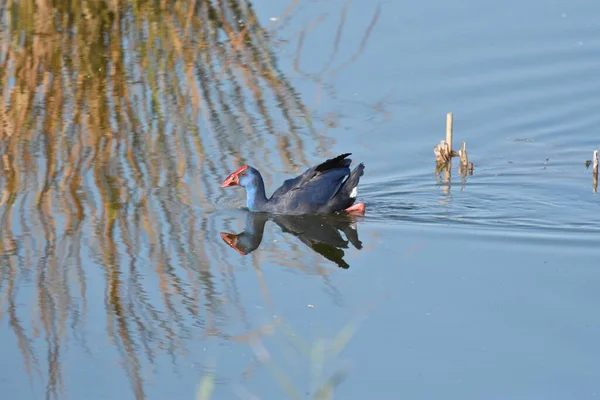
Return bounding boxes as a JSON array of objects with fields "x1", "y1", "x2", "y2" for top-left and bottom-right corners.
[{"x1": 0, "y1": 0, "x2": 600, "y2": 399}]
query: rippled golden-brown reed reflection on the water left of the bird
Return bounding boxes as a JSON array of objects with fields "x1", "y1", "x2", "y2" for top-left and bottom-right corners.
[{"x1": 0, "y1": 0, "x2": 377, "y2": 398}]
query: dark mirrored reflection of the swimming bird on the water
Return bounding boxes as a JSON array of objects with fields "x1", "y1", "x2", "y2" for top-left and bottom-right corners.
[{"x1": 221, "y1": 212, "x2": 362, "y2": 268}]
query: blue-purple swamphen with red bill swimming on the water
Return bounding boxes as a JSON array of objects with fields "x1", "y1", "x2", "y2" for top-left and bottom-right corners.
[{"x1": 221, "y1": 153, "x2": 365, "y2": 215}]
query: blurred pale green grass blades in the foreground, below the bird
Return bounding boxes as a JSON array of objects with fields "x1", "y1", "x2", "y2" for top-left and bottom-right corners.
[{"x1": 196, "y1": 322, "x2": 359, "y2": 400}]
